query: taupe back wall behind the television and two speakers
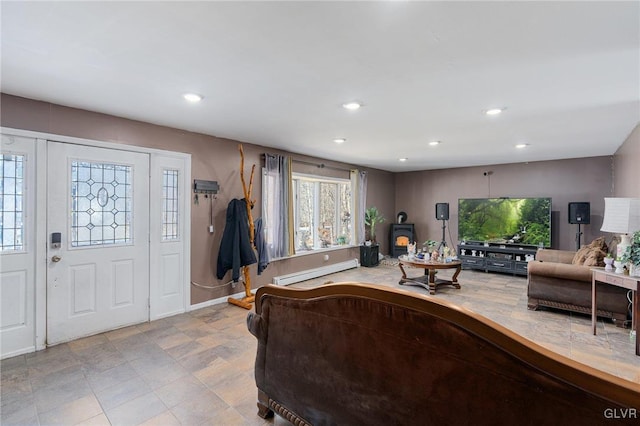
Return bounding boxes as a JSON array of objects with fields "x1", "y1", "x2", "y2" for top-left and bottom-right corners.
[{"x1": 395, "y1": 157, "x2": 612, "y2": 250}]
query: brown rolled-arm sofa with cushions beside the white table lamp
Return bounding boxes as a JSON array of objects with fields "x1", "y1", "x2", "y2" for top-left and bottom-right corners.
[{"x1": 527, "y1": 249, "x2": 629, "y2": 327}]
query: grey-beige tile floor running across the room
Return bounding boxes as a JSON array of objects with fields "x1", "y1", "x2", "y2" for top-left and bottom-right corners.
[{"x1": 0, "y1": 265, "x2": 640, "y2": 425}]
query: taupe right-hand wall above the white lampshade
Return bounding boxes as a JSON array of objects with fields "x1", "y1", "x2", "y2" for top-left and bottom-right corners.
[{"x1": 613, "y1": 123, "x2": 640, "y2": 198}]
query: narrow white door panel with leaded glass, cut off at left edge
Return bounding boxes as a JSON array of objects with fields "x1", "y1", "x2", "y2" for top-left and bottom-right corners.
[{"x1": 0, "y1": 134, "x2": 36, "y2": 358}]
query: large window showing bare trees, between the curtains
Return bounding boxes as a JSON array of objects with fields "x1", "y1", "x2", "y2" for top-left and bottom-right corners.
[{"x1": 293, "y1": 174, "x2": 351, "y2": 252}]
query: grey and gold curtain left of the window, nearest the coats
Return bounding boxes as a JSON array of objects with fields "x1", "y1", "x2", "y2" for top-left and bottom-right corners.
[{"x1": 263, "y1": 154, "x2": 294, "y2": 259}]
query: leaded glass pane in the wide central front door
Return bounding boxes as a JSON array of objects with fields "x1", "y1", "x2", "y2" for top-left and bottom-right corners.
[{"x1": 71, "y1": 161, "x2": 133, "y2": 247}]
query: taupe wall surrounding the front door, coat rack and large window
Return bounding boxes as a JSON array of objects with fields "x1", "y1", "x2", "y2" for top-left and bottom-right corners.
[{"x1": 0, "y1": 94, "x2": 394, "y2": 304}]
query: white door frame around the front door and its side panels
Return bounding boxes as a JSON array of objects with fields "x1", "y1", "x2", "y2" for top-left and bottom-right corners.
[{"x1": 0, "y1": 127, "x2": 191, "y2": 350}]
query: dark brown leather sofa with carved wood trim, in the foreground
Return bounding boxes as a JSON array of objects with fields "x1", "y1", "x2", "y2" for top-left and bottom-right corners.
[{"x1": 247, "y1": 284, "x2": 640, "y2": 425}]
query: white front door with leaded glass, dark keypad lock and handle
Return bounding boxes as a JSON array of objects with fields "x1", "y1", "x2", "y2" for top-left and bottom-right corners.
[{"x1": 47, "y1": 142, "x2": 149, "y2": 345}]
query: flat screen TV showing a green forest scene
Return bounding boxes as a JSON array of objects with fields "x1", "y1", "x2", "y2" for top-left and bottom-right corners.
[{"x1": 458, "y1": 198, "x2": 551, "y2": 247}]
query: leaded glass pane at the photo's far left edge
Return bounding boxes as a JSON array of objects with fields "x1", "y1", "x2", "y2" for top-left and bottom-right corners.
[{"x1": 0, "y1": 154, "x2": 25, "y2": 251}]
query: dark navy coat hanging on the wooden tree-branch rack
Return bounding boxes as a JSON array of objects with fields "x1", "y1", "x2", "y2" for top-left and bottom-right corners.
[{"x1": 217, "y1": 199, "x2": 257, "y2": 282}]
